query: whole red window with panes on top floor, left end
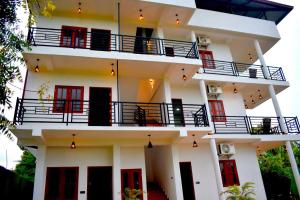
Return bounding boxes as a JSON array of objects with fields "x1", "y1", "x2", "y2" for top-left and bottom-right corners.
[{"x1": 60, "y1": 26, "x2": 87, "y2": 48}]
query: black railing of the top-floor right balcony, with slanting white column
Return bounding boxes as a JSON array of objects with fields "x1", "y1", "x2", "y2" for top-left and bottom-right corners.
[{"x1": 202, "y1": 59, "x2": 286, "y2": 81}]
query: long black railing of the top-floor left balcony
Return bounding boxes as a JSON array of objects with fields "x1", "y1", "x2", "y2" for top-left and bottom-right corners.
[{"x1": 27, "y1": 27, "x2": 199, "y2": 59}]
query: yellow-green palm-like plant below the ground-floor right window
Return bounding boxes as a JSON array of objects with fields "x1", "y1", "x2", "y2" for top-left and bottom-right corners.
[{"x1": 220, "y1": 182, "x2": 255, "y2": 200}]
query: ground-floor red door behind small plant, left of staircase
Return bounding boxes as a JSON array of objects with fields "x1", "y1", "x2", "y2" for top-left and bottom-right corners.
[{"x1": 121, "y1": 169, "x2": 143, "y2": 200}]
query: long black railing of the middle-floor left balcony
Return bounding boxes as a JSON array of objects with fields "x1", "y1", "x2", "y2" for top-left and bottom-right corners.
[{"x1": 14, "y1": 99, "x2": 209, "y2": 127}]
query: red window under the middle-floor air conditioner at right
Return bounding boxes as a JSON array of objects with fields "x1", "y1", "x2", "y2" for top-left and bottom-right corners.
[{"x1": 208, "y1": 100, "x2": 226, "y2": 122}]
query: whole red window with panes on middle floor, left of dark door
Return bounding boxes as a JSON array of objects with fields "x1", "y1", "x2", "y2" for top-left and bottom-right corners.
[{"x1": 53, "y1": 86, "x2": 83, "y2": 113}]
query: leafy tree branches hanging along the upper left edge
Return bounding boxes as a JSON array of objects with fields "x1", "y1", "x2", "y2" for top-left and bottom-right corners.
[{"x1": 0, "y1": 0, "x2": 55, "y2": 138}]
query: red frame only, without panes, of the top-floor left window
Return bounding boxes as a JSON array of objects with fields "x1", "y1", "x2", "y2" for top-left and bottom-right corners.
[{"x1": 60, "y1": 25, "x2": 88, "y2": 48}]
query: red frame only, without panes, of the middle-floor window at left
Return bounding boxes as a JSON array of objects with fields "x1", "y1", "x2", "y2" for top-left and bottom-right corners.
[{"x1": 52, "y1": 85, "x2": 84, "y2": 113}]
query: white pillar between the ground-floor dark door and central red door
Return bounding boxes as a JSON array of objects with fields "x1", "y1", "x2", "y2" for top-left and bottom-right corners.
[{"x1": 113, "y1": 144, "x2": 122, "y2": 200}]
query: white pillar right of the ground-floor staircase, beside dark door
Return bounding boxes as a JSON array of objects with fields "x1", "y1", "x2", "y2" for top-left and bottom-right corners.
[{"x1": 171, "y1": 144, "x2": 183, "y2": 200}]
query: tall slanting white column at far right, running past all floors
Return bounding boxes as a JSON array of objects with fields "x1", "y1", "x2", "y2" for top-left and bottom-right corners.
[{"x1": 254, "y1": 40, "x2": 300, "y2": 194}]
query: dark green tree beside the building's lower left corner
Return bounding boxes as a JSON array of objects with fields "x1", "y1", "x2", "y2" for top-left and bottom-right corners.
[{"x1": 15, "y1": 150, "x2": 36, "y2": 181}]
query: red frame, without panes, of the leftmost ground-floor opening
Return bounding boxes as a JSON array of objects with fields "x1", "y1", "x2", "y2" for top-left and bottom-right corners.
[{"x1": 44, "y1": 167, "x2": 79, "y2": 200}]
